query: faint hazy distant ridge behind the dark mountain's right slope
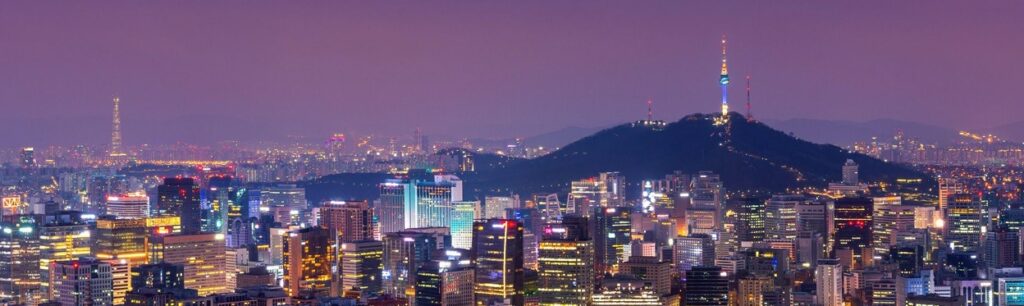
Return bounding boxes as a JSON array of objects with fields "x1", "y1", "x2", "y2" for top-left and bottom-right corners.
[{"x1": 768, "y1": 119, "x2": 957, "y2": 145}]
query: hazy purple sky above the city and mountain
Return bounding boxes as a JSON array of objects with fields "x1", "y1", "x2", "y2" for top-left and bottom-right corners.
[{"x1": 0, "y1": 1, "x2": 1024, "y2": 145}]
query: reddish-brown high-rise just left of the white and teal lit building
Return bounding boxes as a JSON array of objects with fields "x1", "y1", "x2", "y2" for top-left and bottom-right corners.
[{"x1": 318, "y1": 201, "x2": 374, "y2": 243}]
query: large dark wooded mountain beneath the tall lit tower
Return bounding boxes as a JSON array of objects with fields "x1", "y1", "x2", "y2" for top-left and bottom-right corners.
[{"x1": 307, "y1": 114, "x2": 931, "y2": 203}]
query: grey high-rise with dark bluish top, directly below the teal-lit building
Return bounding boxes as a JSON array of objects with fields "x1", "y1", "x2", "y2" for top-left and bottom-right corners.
[{"x1": 381, "y1": 230, "x2": 437, "y2": 297}]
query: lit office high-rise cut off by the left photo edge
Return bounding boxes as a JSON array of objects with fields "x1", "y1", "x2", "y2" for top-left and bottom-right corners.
[{"x1": 0, "y1": 216, "x2": 43, "y2": 304}]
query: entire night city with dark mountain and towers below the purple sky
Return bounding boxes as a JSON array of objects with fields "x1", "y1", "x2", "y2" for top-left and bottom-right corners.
[{"x1": 0, "y1": 1, "x2": 1024, "y2": 306}]
